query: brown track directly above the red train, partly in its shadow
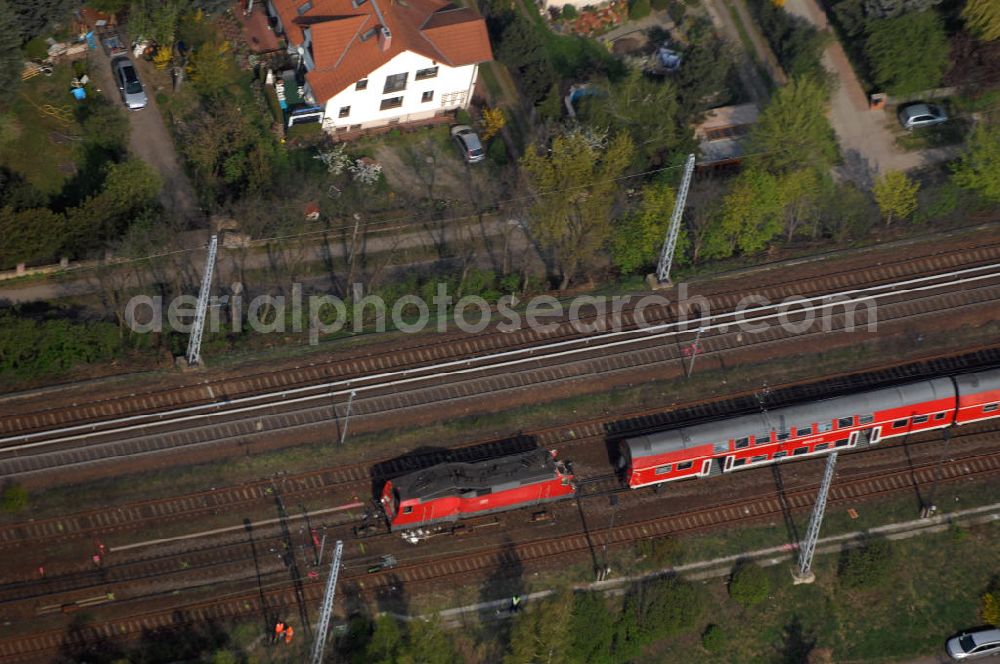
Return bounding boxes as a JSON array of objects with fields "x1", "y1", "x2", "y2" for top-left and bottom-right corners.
[{"x1": 0, "y1": 346, "x2": 1000, "y2": 551}]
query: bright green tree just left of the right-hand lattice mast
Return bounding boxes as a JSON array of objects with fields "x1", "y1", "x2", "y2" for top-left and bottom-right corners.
[{"x1": 611, "y1": 182, "x2": 687, "y2": 274}]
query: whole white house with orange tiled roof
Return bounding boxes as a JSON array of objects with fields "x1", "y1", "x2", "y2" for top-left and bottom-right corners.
[{"x1": 267, "y1": 0, "x2": 493, "y2": 133}]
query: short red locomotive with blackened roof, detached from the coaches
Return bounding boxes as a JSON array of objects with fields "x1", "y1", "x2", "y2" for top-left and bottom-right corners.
[{"x1": 381, "y1": 449, "x2": 576, "y2": 531}]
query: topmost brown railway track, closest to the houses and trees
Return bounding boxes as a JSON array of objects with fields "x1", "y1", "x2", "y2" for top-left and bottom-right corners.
[{"x1": 0, "y1": 239, "x2": 1000, "y2": 438}]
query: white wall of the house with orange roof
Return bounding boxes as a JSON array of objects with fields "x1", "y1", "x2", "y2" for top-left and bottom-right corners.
[{"x1": 323, "y1": 51, "x2": 479, "y2": 132}]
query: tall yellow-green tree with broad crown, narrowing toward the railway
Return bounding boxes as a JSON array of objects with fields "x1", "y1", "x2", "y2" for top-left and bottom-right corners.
[{"x1": 521, "y1": 131, "x2": 634, "y2": 288}]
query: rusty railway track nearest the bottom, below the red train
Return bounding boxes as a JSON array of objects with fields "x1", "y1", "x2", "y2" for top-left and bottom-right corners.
[{"x1": 0, "y1": 436, "x2": 1000, "y2": 663}]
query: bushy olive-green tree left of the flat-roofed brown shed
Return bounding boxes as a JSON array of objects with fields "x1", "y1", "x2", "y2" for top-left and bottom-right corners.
[{"x1": 580, "y1": 70, "x2": 690, "y2": 168}]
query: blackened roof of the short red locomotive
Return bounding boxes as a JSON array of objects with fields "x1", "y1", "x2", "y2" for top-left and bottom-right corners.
[{"x1": 392, "y1": 449, "x2": 556, "y2": 500}]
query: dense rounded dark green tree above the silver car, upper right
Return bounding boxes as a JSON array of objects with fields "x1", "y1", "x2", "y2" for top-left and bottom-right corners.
[{"x1": 865, "y1": 10, "x2": 948, "y2": 96}]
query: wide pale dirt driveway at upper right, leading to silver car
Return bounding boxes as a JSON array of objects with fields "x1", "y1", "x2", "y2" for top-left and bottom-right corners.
[{"x1": 785, "y1": 0, "x2": 955, "y2": 188}]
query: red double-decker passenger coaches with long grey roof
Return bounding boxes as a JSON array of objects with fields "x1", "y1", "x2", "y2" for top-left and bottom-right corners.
[{"x1": 619, "y1": 369, "x2": 1000, "y2": 488}]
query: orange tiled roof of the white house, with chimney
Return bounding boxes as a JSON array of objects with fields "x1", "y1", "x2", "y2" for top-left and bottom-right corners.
[{"x1": 273, "y1": 0, "x2": 493, "y2": 103}]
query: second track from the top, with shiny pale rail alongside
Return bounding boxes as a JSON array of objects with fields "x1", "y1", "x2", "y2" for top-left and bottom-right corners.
[{"x1": 0, "y1": 264, "x2": 1000, "y2": 477}]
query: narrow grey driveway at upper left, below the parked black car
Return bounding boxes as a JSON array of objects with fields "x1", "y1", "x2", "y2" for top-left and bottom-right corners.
[{"x1": 90, "y1": 42, "x2": 204, "y2": 227}]
